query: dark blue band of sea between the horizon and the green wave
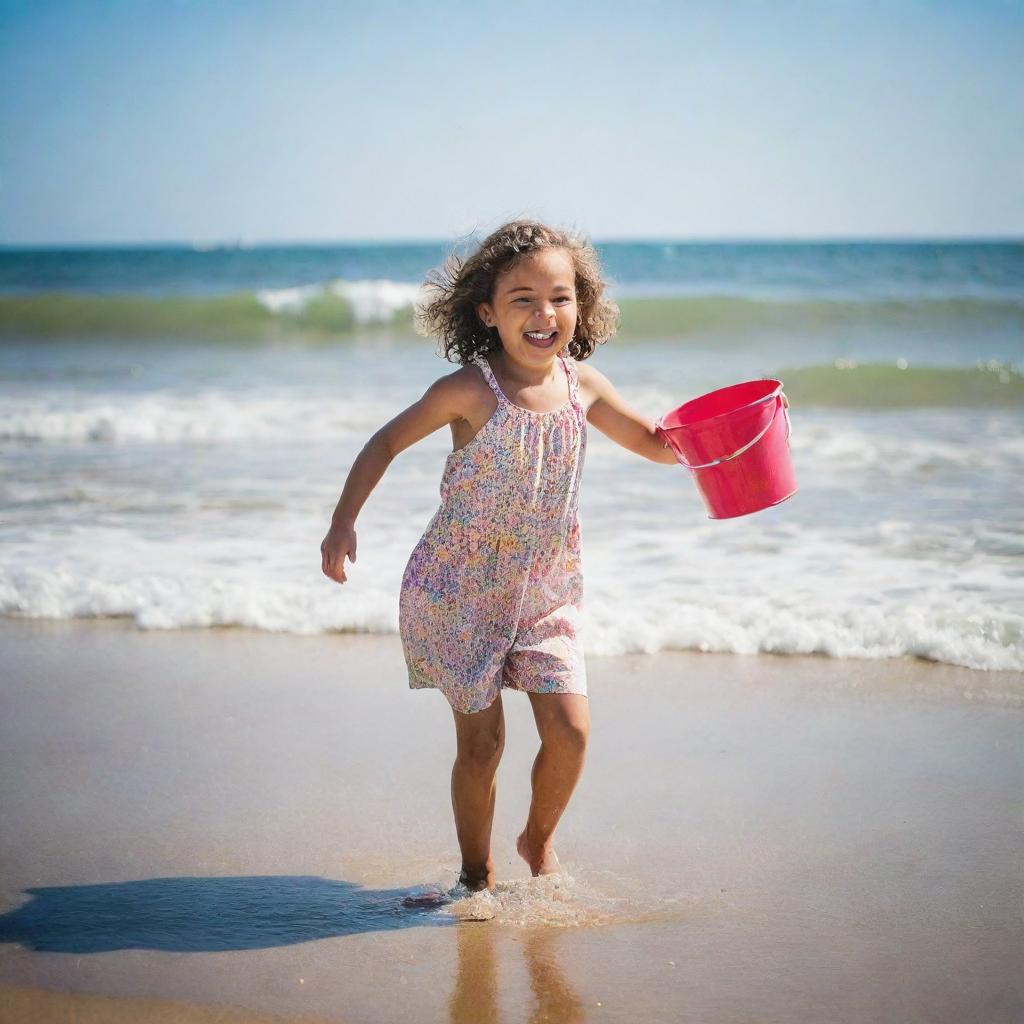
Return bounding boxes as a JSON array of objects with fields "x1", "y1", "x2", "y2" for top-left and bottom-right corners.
[{"x1": 0, "y1": 242, "x2": 1024, "y2": 303}]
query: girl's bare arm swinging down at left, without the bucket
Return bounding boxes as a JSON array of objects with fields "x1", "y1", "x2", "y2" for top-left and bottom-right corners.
[{"x1": 321, "y1": 370, "x2": 473, "y2": 583}]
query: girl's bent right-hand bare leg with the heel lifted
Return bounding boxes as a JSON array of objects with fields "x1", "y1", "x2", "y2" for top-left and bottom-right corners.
[{"x1": 516, "y1": 693, "x2": 590, "y2": 874}]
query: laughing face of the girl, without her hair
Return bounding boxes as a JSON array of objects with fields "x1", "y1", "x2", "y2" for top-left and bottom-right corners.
[{"x1": 476, "y1": 249, "x2": 577, "y2": 369}]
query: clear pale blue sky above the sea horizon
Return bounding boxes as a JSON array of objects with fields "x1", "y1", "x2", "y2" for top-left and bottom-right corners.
[{"x1": 0, "y1": 0, "x2": 1024, "y2": 244}]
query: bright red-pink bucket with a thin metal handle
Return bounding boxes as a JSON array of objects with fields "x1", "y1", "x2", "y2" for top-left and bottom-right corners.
[{"x1": 654, "y1": 380, "x2": 797, "y2": 519}]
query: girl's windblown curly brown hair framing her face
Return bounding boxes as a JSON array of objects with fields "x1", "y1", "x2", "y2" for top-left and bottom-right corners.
[{"x1": 415, "y1": 220, "x2": 618, "y2": 366}]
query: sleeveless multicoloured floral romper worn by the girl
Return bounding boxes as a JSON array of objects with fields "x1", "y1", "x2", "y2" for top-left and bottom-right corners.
[{"x1": 399, "y1": 354, "x2": 587, "y2": 714}]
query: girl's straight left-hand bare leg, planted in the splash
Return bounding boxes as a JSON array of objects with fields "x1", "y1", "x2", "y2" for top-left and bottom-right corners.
[{"x1": 452, "y1": 694, "x2": 505, "y2": 891}]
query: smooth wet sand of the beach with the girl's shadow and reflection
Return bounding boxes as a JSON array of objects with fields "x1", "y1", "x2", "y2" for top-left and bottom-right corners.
[{"x1": 0, "y1": 620, "x2": 1024, "y2": 1024}]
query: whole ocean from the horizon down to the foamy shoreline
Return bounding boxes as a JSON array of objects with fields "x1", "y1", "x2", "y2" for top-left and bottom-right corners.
[{"x1": 0, "y1": 242, "x2": 1024, "y2": 671}]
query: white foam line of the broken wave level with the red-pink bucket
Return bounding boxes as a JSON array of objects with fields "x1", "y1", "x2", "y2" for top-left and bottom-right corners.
[{"x1": 8, "y1": 387, "x2": 1024, "y2": 491}]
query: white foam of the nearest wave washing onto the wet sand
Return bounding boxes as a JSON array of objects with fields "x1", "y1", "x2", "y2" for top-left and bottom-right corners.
[{"x1": 0, "y1": 507, "x2": 1024, "y2": 671}]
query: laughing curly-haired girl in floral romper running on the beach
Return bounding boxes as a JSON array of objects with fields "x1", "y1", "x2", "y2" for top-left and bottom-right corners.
[{"x1": 321, "y1": 220, "x2": 676, "y2": 891}]
